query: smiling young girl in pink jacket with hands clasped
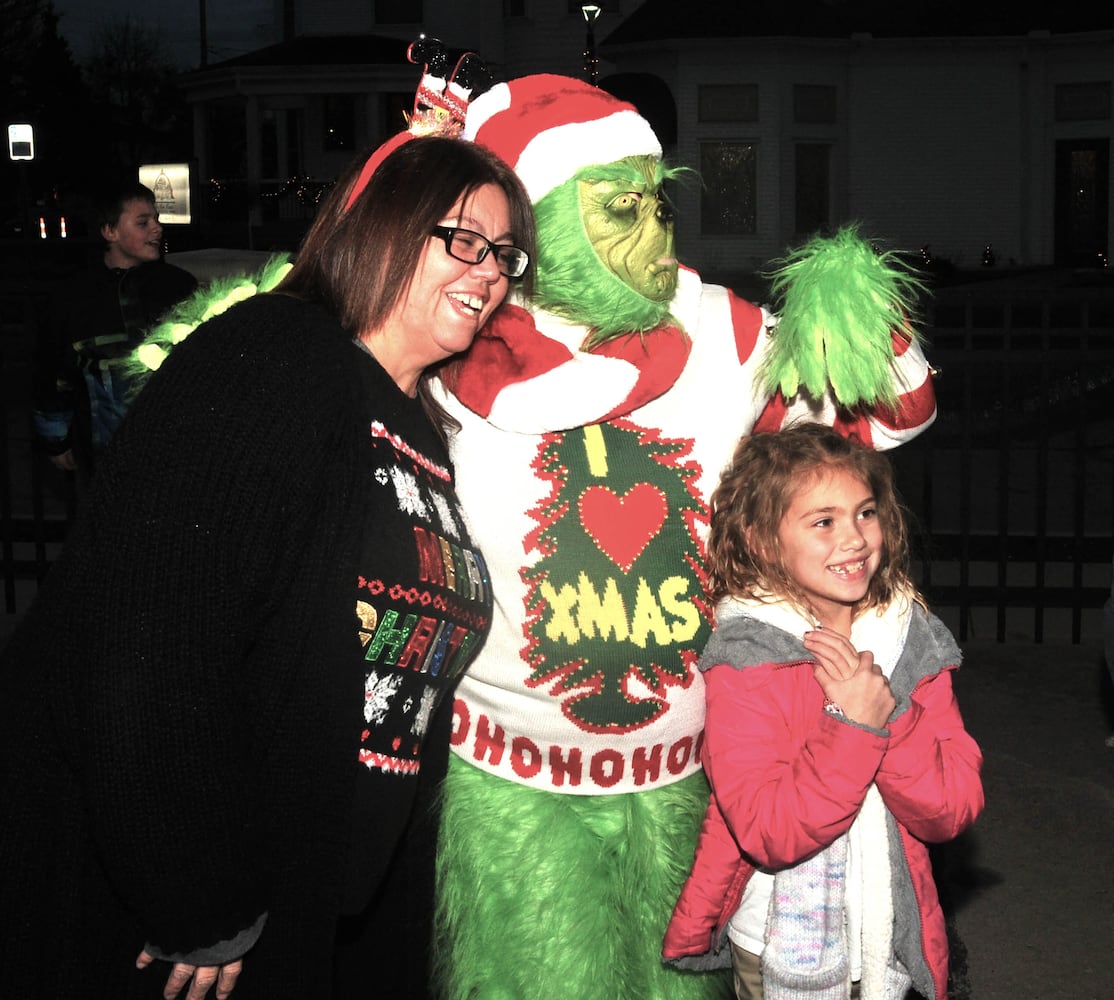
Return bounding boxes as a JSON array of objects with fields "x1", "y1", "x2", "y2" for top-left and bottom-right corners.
[{"x1": 663, "y1": 424, "x2": 983, "y2": 1000}]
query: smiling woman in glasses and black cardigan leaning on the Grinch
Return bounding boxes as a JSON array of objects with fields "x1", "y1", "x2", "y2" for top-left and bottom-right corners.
[{"x1": 0, "y1": 137, "x2": 534, "y2": 1000}]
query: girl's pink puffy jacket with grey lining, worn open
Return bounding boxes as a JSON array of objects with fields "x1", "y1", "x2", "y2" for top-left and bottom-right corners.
[{"x1": 663, "y1": 606, "x2": 984, "y2": 1000}]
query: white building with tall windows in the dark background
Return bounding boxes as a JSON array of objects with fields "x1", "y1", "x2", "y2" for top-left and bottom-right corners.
[{"x1": 185, "y1": 0, "x2": 1114, "y2": 273}]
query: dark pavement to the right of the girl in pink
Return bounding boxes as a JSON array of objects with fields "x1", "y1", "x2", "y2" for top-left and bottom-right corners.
[{"x1": 938, "y1": 639, "x2": 1114, "y2": 1000}]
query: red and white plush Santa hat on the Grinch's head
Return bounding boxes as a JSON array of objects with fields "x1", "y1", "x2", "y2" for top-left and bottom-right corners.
[{"x1": 463, "y1": 73, "x2": 662, "y2": 202}]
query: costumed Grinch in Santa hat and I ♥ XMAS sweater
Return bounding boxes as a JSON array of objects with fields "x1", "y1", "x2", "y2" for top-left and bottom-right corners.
[{"x1": 437, "y1": 76, "x2": 935, "y2": 1000}]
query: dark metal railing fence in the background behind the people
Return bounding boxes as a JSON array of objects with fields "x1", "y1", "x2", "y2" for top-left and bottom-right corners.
[{"x1": 0, "y1": 267, "x2": 1114, "y2": 643}]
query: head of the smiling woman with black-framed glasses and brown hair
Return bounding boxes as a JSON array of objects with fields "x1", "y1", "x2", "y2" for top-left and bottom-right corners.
[{"x1": 276, "y1": 137, "x2": 534, "y2": 420}]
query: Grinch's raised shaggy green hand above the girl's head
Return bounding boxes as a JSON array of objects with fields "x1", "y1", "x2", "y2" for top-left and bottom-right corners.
[{"x1": 761, "y1": 225, "x2": 926, "y2": 408}]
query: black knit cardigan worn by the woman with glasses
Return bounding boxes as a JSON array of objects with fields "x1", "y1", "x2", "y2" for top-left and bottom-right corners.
[{"x1": 0, "y1": 295, "x2": 490, "y2": 1000}]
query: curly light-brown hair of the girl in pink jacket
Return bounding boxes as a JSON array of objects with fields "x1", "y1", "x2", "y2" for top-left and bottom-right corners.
[{"x1": 707, "y1": 423, "x2": 917, "y2": 614}]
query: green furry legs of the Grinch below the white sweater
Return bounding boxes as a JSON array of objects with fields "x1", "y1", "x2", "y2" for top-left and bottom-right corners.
[{"x1": 436, "y1": 757, "x2": 731, "y2": 1000}]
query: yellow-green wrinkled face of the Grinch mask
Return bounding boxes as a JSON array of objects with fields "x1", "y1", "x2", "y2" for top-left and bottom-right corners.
[{"x1": 579, "y1": 156, "x2": 677, "y2": 302}]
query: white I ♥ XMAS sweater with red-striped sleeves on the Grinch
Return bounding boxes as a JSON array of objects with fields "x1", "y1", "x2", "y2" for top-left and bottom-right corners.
[{"x1": 430, "y1": 269, "x2": 936, "y2": 795}]
